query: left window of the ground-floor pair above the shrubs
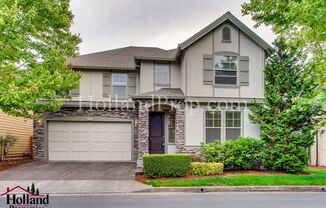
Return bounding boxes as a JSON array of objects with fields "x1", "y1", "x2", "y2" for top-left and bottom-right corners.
[{"x1": 205, "y1": 111, "x2": 222, "y2": 143}]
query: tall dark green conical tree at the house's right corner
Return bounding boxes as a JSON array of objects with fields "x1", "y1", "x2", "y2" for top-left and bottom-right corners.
[{"x1": 250, "y1": 38, "x2": 325, "y2": 173}]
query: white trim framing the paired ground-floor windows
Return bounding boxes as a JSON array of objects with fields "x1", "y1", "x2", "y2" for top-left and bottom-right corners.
[{"x1": 203, "y1": 109, "x2": 244, "y2": 144}]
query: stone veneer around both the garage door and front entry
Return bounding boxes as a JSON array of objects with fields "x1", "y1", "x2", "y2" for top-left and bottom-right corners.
[{"x1": 33, "y1": 101, "x2": 186, "y2": 160}]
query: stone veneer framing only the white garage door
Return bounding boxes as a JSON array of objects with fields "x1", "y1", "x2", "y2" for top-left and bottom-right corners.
[{"x1": 33, "y1": 108, "x2": 138, "y2": 160}]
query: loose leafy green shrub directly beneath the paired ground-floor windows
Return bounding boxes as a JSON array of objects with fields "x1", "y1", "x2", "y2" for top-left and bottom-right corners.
[{"x1": 201, "y1": 137, "x2": 264, "y2": 170}]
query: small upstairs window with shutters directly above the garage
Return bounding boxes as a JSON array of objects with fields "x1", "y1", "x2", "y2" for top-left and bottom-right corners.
[{"x1": 112, "y1": 74, "x2": 128, "y2": 98}]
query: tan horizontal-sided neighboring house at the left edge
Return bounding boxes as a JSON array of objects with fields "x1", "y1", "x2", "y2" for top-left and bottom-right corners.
[{"x1": 0, "y1": 111, "x2": 33, "y2": 158}]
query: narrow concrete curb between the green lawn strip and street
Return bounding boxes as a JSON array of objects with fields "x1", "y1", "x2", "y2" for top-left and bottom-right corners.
[{"x1": 138, "y1": 186, "x2": 326, "y2": 193}]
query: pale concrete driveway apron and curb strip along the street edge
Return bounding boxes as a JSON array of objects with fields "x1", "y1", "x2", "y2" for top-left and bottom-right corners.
[{"x1": 0, "y1": 180, "x2": 326, "y2": 194}]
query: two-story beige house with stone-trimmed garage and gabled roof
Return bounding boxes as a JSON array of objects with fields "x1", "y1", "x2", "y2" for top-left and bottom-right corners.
[{"x1": 34, "y1": 12, "x2": 271, "y2": 166}]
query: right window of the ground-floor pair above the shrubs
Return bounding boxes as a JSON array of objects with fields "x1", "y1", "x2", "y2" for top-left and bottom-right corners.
[{"x1": 225, "y1": 111, "x2": 241, "y2": 140}]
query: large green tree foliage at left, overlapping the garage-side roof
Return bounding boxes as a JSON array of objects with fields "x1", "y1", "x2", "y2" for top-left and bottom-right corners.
[{"x1": 0, "y1": 0, "x2": 80, "y2": 117}]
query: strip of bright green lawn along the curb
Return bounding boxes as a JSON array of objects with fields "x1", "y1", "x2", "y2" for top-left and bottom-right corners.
[{"x1": 144, "y1": 169, "x2": 326, "y2": 187}]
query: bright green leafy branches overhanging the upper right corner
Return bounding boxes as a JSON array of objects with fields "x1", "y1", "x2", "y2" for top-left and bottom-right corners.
[{"x1": 242, "y1": 0, "x2": 326, "y2": 115}]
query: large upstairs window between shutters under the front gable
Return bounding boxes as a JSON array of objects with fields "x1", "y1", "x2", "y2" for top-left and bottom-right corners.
[{"x1": 214, "y1": 56, "x2": 238, "y2": 85}]
